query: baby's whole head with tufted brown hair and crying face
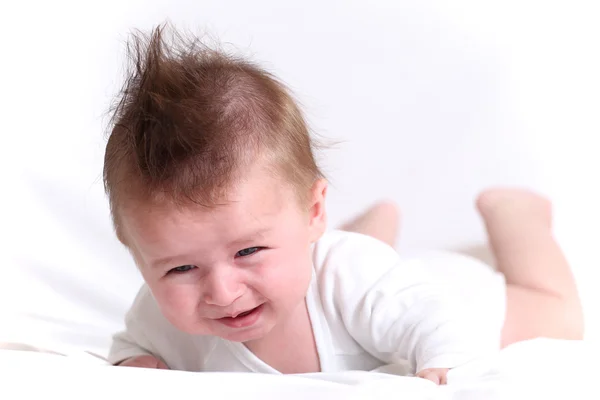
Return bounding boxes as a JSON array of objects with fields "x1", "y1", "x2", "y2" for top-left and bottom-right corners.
[{"x1": 104, "y1": 28, "x2": 327, "y2": 341}]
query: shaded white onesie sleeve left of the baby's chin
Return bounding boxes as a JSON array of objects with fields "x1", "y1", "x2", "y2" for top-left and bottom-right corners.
[{"x1": 108, "y1": 286, "x2": 156, "y2": 365}]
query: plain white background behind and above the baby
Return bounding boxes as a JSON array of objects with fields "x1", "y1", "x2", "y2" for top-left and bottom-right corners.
[{"x1": 0, "y1": 0, "x2": 600, "y2": 356}]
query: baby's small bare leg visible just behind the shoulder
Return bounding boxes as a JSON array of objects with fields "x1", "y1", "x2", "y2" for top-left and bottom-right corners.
[{"x1": 340, "y1": 202, "x2": 400, "y2": 247}]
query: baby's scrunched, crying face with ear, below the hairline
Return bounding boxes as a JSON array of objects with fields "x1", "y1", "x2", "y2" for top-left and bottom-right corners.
[{"x1": 122, "y1": 167, "x2": 326, "y2": 342}]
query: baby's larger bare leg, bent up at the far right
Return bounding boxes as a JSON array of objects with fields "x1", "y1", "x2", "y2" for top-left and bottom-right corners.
[{"x1": 477, "y1": 189, "x2": 583, "y2": 347}]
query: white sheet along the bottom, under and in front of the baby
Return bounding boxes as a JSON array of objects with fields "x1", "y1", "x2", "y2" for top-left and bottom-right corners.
[{"x1": 0, "y1": 339, "x2": 600, "y2": 400}]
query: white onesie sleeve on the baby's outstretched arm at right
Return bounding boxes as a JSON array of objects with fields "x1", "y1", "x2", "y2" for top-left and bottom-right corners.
[{"x1": 317, "y1": 234, "x2": 483, "y2": 372}]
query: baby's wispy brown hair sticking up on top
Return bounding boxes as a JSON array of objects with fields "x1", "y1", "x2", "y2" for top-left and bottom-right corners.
[{"x1": 104, "y1": 26, "x2": 322, "y2": 241}]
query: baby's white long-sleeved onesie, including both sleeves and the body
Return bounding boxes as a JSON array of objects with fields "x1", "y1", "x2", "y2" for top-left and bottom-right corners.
[{"x1": 109, "y1": 231, "x2": 504, "y2": 374}]
